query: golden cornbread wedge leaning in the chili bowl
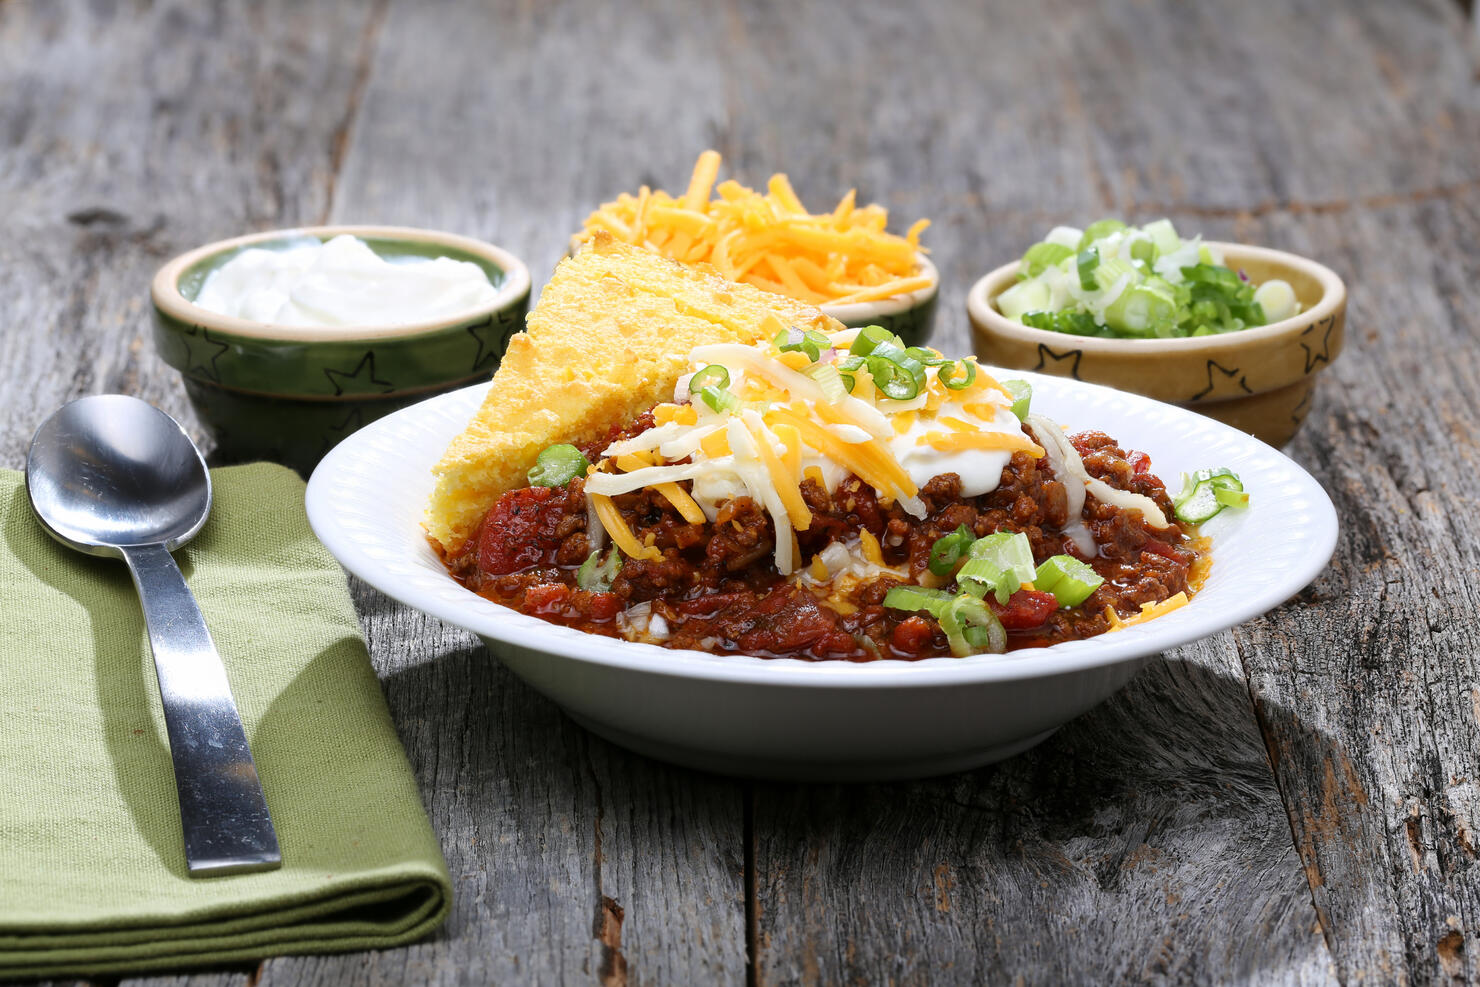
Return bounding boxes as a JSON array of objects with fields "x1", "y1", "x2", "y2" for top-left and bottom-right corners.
[{"x1": 425, "y1": 234, "x2": 842, "y2": 553}]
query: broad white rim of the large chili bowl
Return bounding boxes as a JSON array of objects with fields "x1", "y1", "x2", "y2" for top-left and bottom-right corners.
[{"x1": 305, "y1": 371, "x2": 1339, "y2": 688}]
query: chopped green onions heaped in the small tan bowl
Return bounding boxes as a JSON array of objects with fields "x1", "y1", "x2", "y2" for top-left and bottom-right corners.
[{"x1": 996, "y1": 219, "x2": 1299, "y2": 339}]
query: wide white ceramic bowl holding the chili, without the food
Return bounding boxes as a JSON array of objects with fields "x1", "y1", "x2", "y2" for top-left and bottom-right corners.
[{"x1": 308, "y1": 373, "x2": 1336, "y2": 780}]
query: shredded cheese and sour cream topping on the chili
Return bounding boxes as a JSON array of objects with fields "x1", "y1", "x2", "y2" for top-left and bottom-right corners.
[{"x1": 586, "y1": 320, "x2": 1043, "y2": 576}]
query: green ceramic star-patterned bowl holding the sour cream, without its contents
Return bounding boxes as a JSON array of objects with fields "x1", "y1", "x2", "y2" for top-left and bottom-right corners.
[{"x1": 149, "y1": 226, "x2": 530, "y2": 474}]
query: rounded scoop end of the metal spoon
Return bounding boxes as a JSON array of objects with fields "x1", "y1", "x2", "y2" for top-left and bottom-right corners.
[{"x1": 25, "y1": 394, "x2": 210, "y2": 558}]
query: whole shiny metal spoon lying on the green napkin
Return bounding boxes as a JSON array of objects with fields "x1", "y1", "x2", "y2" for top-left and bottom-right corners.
[{"x1": 25, "y1": 394, "x2": 283, "y2": 877}]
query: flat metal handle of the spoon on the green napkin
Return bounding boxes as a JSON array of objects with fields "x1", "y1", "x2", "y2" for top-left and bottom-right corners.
[{"x1": 123, "y1": 545, "x2": 283, "y2": 877}]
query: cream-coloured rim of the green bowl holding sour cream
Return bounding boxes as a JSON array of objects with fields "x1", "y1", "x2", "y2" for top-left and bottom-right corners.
[{"x1": 149, "y1": 223, "x2": 530, "y2": 343}]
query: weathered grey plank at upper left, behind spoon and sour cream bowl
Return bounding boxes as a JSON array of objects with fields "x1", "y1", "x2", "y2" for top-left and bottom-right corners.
[{"x1": 0, "y1": 1, "x2": 381, "y2": 466}]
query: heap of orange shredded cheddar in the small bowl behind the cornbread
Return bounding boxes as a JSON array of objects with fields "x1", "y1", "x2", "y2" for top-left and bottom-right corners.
[{"x1": 576, "y1": 151, "x2": 931, "y2": 305}]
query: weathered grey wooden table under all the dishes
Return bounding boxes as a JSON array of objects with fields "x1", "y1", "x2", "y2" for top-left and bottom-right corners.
[{"x1": 0, "y1": 0, "x2": 1480, "y2": 984}]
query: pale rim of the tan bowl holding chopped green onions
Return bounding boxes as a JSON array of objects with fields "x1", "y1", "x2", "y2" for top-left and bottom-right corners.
[{"x1": 966, "y1": 240, "x2": 1347, "y2": 355}]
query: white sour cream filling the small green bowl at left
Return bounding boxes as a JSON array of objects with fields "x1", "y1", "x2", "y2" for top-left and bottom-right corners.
[{"x1": 195, "y1": 234, "x2": 497, "y2": 327}]
